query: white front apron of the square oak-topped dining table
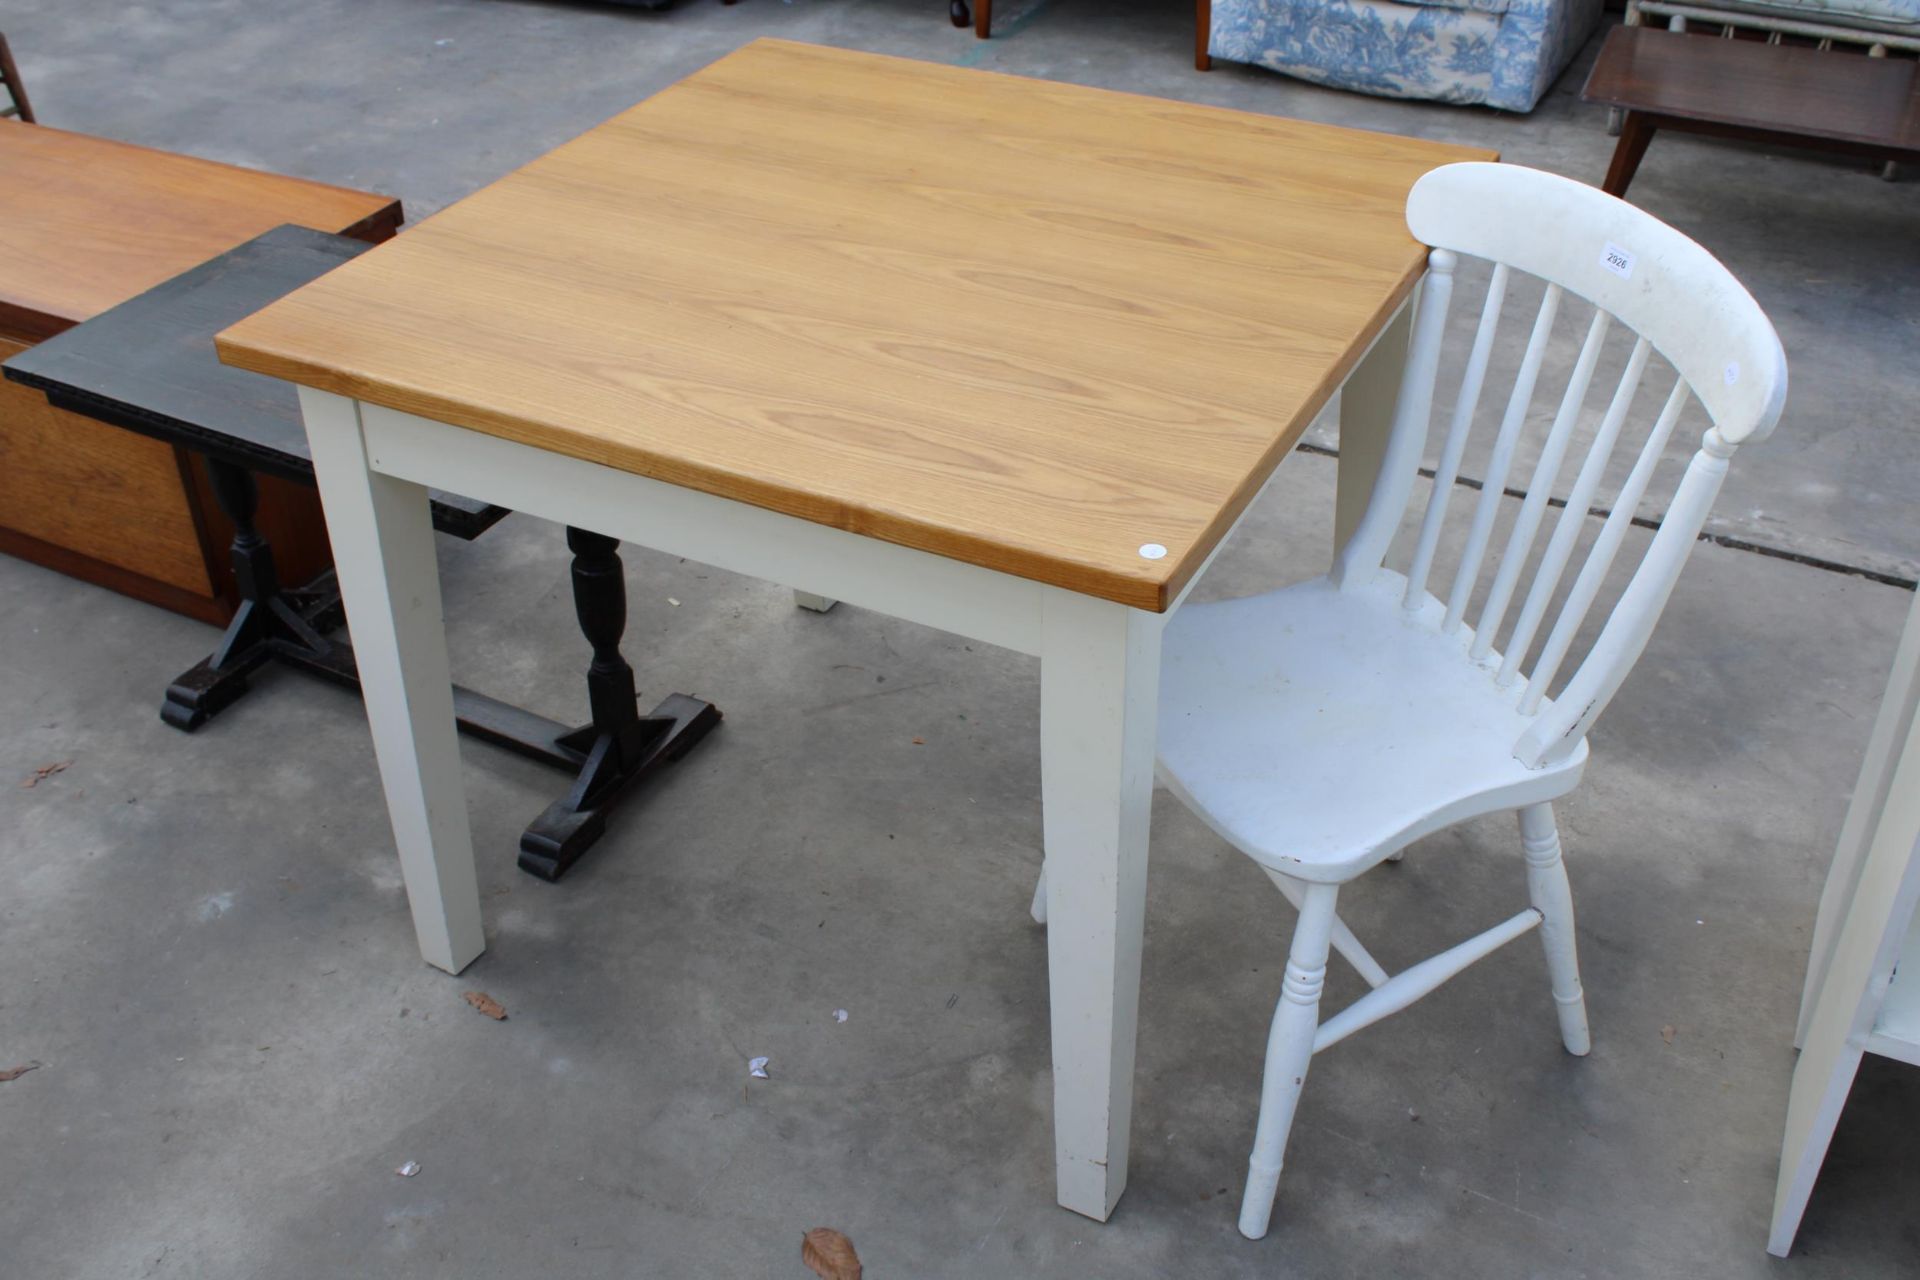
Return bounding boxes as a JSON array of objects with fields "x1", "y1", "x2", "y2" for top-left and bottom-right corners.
[{"x1": 359, "y1": 401, "x2": 1048, "y2": 656}]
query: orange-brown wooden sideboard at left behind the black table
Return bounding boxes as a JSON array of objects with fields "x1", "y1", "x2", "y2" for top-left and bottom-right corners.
[{"x1": 0, "y1": 119, "x2": 401, "y2": 624}]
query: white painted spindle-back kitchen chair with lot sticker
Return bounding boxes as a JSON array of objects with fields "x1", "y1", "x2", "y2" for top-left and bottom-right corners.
[{"x1": 1037, "y1": 163, "x2": 1786, "y2": 1240}]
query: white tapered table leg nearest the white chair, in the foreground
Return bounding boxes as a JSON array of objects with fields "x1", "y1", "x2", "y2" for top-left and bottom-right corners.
[{"x1": 1041, "y1": 591, "x2": 1164, "y2": 1222}]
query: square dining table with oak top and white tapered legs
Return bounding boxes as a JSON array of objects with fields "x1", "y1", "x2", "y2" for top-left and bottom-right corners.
[{"x1": 219, "y1": 40, "x2": 1494, "y2": 1221}]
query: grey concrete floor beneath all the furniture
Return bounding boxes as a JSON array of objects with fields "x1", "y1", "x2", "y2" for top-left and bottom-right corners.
[{"x1": 0, "y1": 0, "x2": 1920, "y2": 1278}]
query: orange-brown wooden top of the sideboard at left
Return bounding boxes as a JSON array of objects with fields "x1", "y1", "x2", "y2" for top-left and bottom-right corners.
[{"x1": 0, "y1": 121, "x2": 399, "y2": 338}]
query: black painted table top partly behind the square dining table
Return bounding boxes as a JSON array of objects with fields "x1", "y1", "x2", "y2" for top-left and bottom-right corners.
[{"x1": 4, "y1": 225, "x2": 507, "y2": 537}]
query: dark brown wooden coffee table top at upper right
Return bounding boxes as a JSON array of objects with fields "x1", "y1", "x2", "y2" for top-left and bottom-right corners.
[{"x1": 1580, "y1": 27, "x2": 1920, "y2": 150}]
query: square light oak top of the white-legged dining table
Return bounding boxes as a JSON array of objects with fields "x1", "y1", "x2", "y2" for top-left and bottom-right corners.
[{"x1": 219, "y1": 40, "x2": 1492, "y2": 610}]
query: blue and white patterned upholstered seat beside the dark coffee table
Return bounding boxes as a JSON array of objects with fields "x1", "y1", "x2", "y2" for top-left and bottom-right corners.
[{"x1": 1208, "y1": 0, "x2": 1601, "y2": 111}]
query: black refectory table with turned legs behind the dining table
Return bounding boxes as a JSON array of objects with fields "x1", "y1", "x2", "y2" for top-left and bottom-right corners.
[{"x1": 4, "y1": 226, "x2": 720, "y2": 879}]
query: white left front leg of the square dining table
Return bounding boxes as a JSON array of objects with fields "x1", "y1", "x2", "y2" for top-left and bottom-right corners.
[{"x1": 300, "y1": 388, "x2": 486, "y2": 973}]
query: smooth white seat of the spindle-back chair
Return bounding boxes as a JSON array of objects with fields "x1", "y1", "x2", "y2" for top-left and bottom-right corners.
[{"x1": 1160, "y1": 570, "x2": 1586, "y2": 881}]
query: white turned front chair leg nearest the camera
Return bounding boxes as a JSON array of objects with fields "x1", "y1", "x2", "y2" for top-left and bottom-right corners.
[{"x1": 1240, "y1": 885, "x2": 1340, "y2": 1240}]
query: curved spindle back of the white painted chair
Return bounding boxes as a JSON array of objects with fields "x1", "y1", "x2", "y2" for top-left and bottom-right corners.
[{"x1": 1332, "y1": 163, "x2": 1788, "y2": 768}]
